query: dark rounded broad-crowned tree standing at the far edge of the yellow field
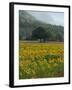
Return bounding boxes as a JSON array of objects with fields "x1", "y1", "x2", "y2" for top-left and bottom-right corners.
[{"x1": 32, "y1": 27, "x2": 48, "y2": 42}]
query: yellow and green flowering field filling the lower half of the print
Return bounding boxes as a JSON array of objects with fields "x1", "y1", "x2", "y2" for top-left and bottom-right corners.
[{"x1": 19, "y1": 41, "x2": 64, "y2": 79}]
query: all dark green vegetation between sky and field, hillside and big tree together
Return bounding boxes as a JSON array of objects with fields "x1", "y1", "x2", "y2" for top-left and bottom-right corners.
[{"x1": 19, "y1": 10, "x2": 64, "y2": 42}]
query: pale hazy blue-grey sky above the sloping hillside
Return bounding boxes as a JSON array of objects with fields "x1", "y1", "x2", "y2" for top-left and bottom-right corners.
[{"x1": 27, "y1": 11, "x2": 64, "y2": 26}]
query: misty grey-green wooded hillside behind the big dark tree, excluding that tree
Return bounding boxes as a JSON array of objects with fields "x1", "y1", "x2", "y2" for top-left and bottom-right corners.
[{"x1": 19, "y1": 10, "x2": 64, "y2": 41}]
